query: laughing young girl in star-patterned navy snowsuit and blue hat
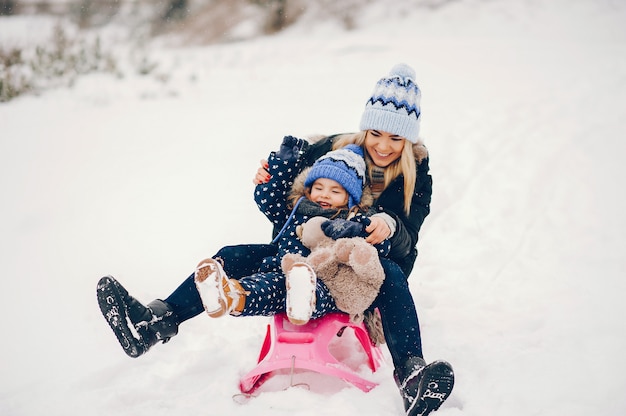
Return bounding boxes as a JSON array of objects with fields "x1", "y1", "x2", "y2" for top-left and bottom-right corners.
[{"x1": 195, "y1": 141, "x2": 389, "y2": 325}]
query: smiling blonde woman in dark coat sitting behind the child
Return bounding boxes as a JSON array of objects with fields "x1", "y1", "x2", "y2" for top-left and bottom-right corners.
[{"x1": 95, "y1": 64, "x2": 454, "y2": 416}]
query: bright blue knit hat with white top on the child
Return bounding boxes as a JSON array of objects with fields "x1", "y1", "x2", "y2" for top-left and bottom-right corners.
[{"x1": 304, "y1": 144, "x2": 365, "y2": 208}]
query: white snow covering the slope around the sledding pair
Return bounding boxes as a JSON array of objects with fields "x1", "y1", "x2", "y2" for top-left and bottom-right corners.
[{"x1": 0, "y1": 0, "x2": 626, "y2": 416}]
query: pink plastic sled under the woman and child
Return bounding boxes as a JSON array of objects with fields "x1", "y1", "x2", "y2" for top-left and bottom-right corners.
[{"x1": 239, "y1": 313, "x2": 382, "y2": 394}]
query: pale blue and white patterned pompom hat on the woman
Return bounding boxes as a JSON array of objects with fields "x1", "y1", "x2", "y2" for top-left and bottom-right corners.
[{"x1": 360, "y1": 64, "x2": 422, "y2": 143}]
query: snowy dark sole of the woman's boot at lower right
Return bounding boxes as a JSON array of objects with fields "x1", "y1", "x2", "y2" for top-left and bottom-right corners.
[{"x1": 406, "y1": 361, "x2": 454, "y2": 416}]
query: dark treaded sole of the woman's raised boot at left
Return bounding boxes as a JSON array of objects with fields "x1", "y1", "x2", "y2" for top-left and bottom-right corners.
[{"x1": 97, "y1": 276, "x2": 145, "y2": 358}]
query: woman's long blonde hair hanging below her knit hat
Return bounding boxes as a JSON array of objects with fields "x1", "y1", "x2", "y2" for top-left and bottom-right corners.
[{"x1": 333, "y1": 131, "x2": 414, "y2": 215}]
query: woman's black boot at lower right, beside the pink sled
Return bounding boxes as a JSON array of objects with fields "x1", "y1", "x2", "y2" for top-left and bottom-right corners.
[{"x1": 394, "y1": 357, "x2": 454, "y2": 416}]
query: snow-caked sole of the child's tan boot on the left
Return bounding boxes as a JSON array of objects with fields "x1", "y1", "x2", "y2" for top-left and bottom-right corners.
[{"x1": 194, "y1": 259, "x2": 228, "y2": 318}]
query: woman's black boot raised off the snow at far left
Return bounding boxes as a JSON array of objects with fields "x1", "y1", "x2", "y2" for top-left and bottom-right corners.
[{"x1": 97, "y1": 276, "x2": 179, "y2": 358}]
